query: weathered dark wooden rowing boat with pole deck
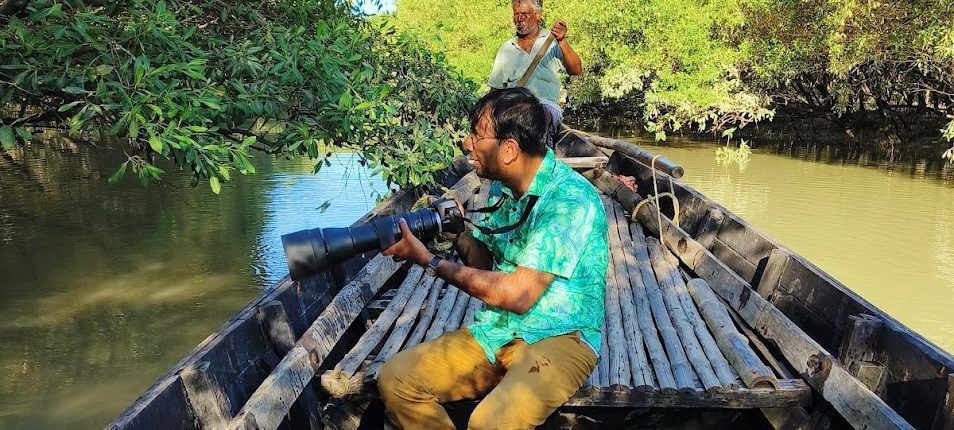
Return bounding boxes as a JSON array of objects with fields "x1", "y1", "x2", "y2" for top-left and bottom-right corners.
[{"x1": 109, "y1": 130, "x2": 954, "y2": 429}]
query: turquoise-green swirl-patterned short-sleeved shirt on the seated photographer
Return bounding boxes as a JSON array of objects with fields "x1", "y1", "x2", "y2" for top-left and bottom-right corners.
[{"x1": 468, "y1": 150, "x2": 609, "y2": 363}]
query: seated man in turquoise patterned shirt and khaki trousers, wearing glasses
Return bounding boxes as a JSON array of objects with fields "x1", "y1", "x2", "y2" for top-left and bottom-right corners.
[{"x1": 378, "y1": 88, "x2": 608, "y2": 429}]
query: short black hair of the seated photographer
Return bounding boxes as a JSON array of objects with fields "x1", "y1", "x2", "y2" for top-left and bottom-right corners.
[{"x1": 470, "y1": 87, "x2": 547, "y2": 157}]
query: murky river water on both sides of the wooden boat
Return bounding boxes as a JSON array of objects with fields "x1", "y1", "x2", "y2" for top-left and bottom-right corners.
[{"x1": 0, "y1": 133, "x2": 954, "y2": 429}]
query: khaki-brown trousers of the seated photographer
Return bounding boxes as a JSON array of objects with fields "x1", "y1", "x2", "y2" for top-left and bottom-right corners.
[{"x1": 378, "y1": 328, "x2": 596, "y2": 430}]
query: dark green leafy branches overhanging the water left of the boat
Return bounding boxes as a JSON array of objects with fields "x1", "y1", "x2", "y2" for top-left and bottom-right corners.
[{"x1": 0, "y1": 0, "x2": 476, "y2": 193}]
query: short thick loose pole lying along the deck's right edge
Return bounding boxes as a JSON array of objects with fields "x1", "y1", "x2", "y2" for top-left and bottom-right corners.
[{"x1": 688, "y1": 279, "x2": 779, "y2": 389}]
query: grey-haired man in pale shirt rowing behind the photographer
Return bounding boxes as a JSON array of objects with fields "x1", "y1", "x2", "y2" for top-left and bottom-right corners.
[{"x1": 487, "y1": 0, "x2": 583, "y2": 103}]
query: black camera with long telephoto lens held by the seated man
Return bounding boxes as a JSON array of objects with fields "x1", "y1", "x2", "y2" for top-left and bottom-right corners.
[{"x1": 282, "y1": 199, "x2": 464, "y2": 281}]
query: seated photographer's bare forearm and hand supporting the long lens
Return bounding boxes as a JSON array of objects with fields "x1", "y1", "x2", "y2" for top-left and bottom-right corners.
[{"x1": 382, "y1": 218, "x2": 555, "y2": 315}]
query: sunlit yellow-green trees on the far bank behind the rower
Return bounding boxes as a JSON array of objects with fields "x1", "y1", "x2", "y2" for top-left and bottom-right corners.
[{"x1": 392, "y1": 0, "x2": 954, "y2": 153}]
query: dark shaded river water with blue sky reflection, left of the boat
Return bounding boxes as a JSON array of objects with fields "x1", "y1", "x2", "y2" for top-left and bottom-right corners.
[{"x1": 0, "y1": 138, "x2": 387, "y2": 429}]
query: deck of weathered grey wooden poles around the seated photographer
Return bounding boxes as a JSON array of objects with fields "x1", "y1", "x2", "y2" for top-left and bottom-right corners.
[{"x1": 316, "y1": 187, "x2": 811, "y2": 409}]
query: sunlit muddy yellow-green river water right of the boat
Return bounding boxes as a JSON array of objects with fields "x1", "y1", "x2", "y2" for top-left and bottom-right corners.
[{"x1": 596, "y1": 131, "x2": 954, "y2": 351}]
